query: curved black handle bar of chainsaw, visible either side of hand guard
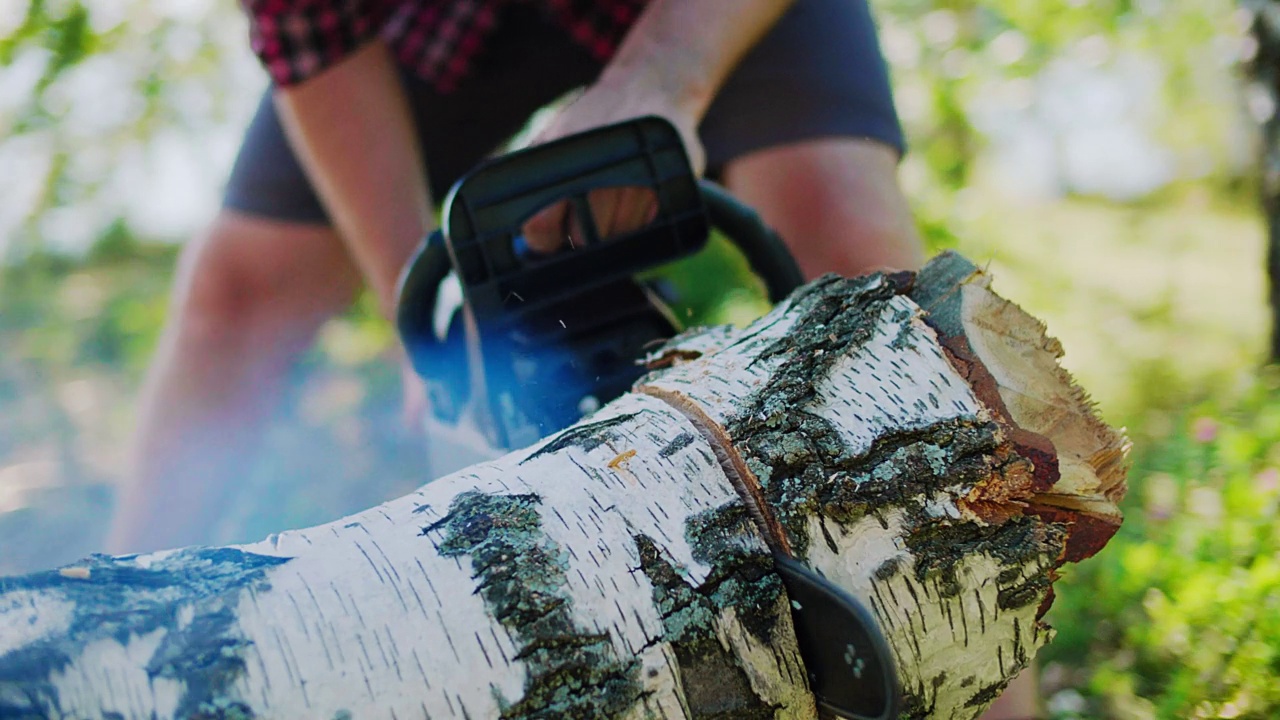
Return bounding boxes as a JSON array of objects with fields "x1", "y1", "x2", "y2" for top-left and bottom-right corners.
[{"x1": 397, "y1": 179, "x2": 804, "y2": 375}]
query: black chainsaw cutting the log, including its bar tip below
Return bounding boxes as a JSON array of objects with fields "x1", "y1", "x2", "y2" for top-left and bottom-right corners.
[{"x1": 397, "y1": 117, "x2": 899, "y2": 719}]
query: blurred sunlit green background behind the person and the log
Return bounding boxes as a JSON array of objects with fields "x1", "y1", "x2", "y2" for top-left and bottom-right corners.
[{"x1": 0, "y1": 0, "x2": 1280, "y2": 717}]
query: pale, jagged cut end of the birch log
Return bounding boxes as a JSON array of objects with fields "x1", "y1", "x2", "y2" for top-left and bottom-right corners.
[{"x1": 911, "y1": 252, "x2": 1130, "y2": 562}]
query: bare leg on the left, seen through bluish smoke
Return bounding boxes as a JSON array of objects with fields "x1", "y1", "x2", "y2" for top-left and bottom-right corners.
[{"x1": 109, "y1": 211, "x2": 361, "y2": 552}]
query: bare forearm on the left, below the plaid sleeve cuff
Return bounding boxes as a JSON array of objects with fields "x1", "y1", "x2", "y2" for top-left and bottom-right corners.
[{"x1": 275, "y1": 40, "x2": 433, "y2": 316}]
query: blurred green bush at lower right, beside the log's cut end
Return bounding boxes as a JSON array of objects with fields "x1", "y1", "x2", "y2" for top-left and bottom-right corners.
[{"x1": 1043, "y1": 372, "x2": 1280, "y2": 719}]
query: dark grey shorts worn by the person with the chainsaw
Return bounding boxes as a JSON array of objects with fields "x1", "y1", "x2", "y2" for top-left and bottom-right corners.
[{"x1": 224, "y1": 0, "x2": 904, "y2": 223}]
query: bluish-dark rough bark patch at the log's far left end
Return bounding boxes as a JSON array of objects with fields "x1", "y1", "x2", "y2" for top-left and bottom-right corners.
[{"x1": 0, "y1": 548, "x2": 288, "y2": 719}]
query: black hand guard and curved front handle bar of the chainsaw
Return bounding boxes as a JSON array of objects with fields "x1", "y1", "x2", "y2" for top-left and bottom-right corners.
[{"x1": 397, "y1": 117, "x2": 803, "y2": 374}]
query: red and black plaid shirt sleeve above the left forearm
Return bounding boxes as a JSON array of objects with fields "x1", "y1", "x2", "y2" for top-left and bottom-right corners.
[{"x1": 242, "y1": 0, "x2": 389, "y2": 86}]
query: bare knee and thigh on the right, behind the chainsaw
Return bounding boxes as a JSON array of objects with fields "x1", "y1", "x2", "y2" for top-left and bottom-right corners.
[{"x1": 724, "y1": 138, "x2": 923, "y2": 278}]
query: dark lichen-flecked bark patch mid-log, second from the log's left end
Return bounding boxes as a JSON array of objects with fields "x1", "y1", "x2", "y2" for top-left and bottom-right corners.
[{"x1": 424, "y1": 486, "x2": 644, "y2": 720}]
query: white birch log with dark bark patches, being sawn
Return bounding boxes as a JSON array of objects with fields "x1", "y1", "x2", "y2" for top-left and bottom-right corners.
[{"x1": 0, "y1": 249, "x2": 1125, "y2": 720}]
